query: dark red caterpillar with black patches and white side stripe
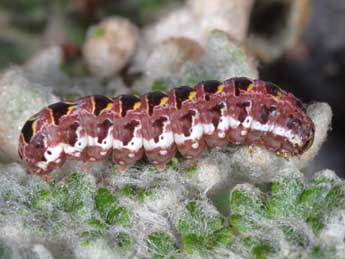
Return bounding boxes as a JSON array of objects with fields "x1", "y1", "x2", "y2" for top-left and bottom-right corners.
[{"x1": 18, "y1": 77, "x2": 315, "y2": 175}]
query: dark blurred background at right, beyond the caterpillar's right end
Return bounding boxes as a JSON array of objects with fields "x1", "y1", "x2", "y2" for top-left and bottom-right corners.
[{"x1": 259, "y1": 0, "x2": 345, "y2": 177}]
